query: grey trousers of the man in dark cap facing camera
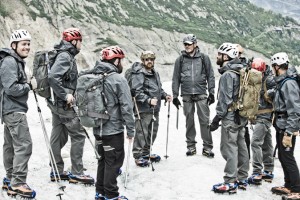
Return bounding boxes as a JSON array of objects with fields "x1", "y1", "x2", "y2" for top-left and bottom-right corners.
[{"x1": 182, "y1": 95, "x2": 213, "y2": 150}]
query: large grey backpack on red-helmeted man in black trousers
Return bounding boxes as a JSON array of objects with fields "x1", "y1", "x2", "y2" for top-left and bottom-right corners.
[{"x1": 75, "y1": 70, "x2": 116, "y2": 127}]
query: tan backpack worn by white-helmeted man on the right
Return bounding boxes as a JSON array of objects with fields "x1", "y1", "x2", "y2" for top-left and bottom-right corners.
[{"x1": 229, "y1": 67, "x2": 262, "y2": 120}]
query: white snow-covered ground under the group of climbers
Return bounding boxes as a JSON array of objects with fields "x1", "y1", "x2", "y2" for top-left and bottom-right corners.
[{"x1": 0, "y1": 82, "x2": 300, "y2": 200}]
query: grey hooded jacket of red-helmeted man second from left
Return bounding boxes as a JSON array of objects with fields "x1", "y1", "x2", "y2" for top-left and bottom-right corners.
[{"x1": 48, "y1": 40, "x2": 79, "y2": 107}]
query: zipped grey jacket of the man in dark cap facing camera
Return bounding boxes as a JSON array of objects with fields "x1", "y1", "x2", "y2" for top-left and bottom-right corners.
[{"x1": 172, "y1": 47, "x2": 215, "y2": 98}]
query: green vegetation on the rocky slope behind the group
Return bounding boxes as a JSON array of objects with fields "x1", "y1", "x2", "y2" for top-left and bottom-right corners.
[{"x1": 20, "y1": 0, "x2": 300, "y2": 65}]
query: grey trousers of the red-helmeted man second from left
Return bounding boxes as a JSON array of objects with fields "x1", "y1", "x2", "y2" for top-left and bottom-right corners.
[{"x1": 50, "y1": 112, "x2": 85, "y2": 175}]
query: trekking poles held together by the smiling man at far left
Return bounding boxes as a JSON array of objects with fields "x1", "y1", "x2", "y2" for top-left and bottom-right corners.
[{"x1": 33, "y1": 90, "x2": 66, "y2": 200}]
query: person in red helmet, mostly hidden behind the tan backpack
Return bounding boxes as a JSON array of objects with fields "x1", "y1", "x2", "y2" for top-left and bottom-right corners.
[{"x1": 248, "y1": 58, "x2": 276, "y2": 185}]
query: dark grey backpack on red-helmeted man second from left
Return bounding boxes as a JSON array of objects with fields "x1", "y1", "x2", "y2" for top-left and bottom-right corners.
[{"x1": 32, "y1": 49, "x2": 73, "y2": 100}]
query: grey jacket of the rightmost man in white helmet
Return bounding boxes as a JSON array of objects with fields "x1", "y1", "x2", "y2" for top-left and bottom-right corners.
[{"x1": 273, "y1": 67, "x2": 300, "y2": 132}]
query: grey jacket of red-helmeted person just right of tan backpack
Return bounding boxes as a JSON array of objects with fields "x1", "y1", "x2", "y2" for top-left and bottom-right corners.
[{"x1": 257, "y1": 66, "x2": 276, "y2": 121}]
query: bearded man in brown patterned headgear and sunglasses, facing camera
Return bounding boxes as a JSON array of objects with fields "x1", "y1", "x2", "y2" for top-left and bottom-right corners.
[{"x1": 131, "y1": 51, "x2": 172, "y2": 167}]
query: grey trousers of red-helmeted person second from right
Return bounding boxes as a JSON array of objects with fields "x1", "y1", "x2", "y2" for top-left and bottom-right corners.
[{"x1": 251, "y1": 120, "x2": 274, "y2": 174}]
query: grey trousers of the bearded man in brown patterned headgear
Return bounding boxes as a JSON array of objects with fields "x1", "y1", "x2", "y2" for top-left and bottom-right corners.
[{"x1": 132, "y1": 112, "x2": 159, "y2": 159}]
